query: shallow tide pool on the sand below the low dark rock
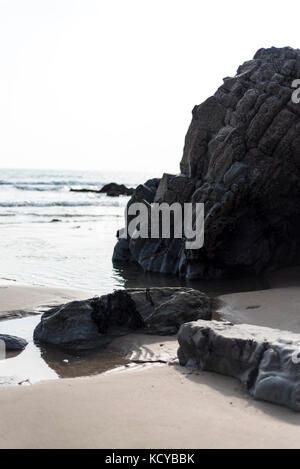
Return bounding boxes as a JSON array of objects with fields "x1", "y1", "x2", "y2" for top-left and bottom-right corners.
[{"x1": 0, "y1": 315, "x2": 128, "y2": 385}]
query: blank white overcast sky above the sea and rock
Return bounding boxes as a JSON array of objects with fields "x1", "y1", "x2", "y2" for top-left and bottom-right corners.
[{"x1": 0, "y1": 0, "x2": 300, "y2": 173}]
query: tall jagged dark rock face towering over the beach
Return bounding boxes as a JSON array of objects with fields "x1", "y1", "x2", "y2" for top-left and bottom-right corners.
[{"x1": 113, "y1": 48, "x2": 300, "y2": 278}]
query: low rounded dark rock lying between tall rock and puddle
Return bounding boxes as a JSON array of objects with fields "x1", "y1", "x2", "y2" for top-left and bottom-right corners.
[{"x1": 34, "y1": 287, "x2": 212, "y2": 351}]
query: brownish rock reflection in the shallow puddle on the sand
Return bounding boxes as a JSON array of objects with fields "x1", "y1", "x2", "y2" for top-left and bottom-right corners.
[{"x1": 41, "y1": 347, "x2": 128, "y2": 378}]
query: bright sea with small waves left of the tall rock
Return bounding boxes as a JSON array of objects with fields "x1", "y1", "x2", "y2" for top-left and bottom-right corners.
[{"x1": 0, "y1": 169, "x2": 163, "y2": 294}]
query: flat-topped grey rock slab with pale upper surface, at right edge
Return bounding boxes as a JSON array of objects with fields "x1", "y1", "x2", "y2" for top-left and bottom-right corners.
[{"x1": 178, "y1": 320, "x2": 300, "y2": 411}]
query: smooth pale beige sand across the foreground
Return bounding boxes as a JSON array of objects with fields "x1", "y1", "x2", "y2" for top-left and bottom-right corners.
[{"x1": 0, "y1": 365, "x2": 300, "y2": 448}]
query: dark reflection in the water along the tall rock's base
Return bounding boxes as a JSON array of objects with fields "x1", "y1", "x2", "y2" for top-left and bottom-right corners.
[{"x1": 114, "y1": 262, "x2": 270, "y2": 296}]
